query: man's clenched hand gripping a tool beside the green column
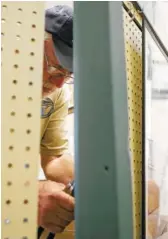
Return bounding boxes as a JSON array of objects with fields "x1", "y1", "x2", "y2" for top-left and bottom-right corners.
[{"x1": 38, "y1": 180, "x2": 75, "y2": 233}]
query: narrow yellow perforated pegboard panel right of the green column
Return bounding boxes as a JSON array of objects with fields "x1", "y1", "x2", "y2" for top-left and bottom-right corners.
[{"x1": 123, "y1": 3, "x2": 142, "y2": 239}]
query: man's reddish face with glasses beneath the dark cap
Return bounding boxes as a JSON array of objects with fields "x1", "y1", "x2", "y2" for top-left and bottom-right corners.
[{"x1": 42, "y1": 38, "x2": 70, "y2": 96}]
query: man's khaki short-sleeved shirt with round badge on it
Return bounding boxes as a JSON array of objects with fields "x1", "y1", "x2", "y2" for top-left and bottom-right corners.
[{"x1": 40, "y1": 88, "x2": 68, "y2": 156}]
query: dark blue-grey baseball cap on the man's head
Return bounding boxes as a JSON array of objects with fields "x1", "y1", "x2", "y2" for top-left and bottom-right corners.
[{"x1": 45, "y1": 5, "x2": 73, "y2": 72}]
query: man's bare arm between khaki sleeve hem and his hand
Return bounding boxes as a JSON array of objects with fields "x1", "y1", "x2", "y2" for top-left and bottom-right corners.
[{"x1": 41, "y1": 154, "x2": 74, "y2": 185}]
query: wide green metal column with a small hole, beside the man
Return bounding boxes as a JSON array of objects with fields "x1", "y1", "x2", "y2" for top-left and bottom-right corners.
[{"x1": 74, "y1": 1, "x2": 133, "y2": 239}]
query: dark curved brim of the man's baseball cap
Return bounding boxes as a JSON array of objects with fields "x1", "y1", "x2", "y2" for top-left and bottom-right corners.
[{"x1": 53, "y1": 39, "x2": 73, "y2": 72}]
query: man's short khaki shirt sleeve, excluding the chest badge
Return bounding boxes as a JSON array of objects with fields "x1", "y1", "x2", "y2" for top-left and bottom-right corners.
[{"x1": 41, "y1": 88, "x2": 68, "y2": 156}]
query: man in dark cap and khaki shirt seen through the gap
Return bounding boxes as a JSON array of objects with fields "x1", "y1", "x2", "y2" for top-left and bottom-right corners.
[{"x1": 38, "y1": 6, "x2": 74, "y2": 233}]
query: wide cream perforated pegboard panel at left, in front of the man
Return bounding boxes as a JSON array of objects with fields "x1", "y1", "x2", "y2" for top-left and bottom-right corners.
[{"x1": 1, "y1": 1, "x2": 44, "y2": 239}]
